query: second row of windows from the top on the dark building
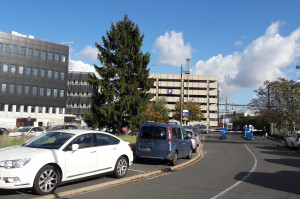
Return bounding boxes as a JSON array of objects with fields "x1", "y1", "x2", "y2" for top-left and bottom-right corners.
[{"x1": 2, "y1": 64, "x2": 66, "y2": 80}]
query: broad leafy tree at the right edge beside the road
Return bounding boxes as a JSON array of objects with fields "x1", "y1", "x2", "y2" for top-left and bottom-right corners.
[{"x1": 251, "y1": 78, "x2": 300, "y2": 131}]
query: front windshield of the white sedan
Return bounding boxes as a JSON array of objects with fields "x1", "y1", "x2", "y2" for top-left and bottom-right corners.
[{"x1": 23, "y1": 132, "x2": 75, "y2": 149}]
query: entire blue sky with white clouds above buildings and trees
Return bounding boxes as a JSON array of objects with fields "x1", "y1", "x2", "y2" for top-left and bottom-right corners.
[{"x1": 0, "y1": 0, "x2": 300, "y2": 111}]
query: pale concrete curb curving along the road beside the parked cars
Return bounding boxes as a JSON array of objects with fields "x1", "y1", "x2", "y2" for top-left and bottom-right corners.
[{"x1": 35, "y1": 142, "x2": 204, "y2": 199}]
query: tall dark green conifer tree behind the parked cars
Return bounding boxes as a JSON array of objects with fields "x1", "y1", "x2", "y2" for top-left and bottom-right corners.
[{"x1": 85, "y1": 14, "x2": 154, "y2": 132}]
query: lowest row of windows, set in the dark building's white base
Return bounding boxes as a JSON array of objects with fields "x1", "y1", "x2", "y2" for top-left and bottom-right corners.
[{"x1": 0, "y1": 104, "x2": 63, "y2": 114}]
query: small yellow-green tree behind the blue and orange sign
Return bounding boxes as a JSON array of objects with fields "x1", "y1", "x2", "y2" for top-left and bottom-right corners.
[{"x1": 174, "y1": 100, "x2": 203, "y2": 122}]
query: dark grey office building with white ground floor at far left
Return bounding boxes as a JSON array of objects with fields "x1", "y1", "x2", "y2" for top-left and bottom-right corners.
[{"x1": 0, "y1": 32, "x2": 69, "y2": 126}]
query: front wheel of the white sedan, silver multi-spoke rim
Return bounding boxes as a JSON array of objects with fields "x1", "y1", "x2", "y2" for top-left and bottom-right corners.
[{"x1": 33, "y1": 165, "x2": 60, "y2": 195}]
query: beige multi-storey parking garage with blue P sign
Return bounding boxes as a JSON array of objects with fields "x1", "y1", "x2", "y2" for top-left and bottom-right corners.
[{"x1": 150, "y1": 74, "x2": 219, "y2": 127}]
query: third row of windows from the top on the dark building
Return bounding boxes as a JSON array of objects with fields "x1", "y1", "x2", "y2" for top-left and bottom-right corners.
[{"x1": 1, "y1": 84, "x2": 65, "y2": 97}]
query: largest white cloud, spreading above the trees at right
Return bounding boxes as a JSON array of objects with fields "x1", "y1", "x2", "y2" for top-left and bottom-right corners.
[{"x1": 192, "y1": 22, "x2": 300, "y2": 101}]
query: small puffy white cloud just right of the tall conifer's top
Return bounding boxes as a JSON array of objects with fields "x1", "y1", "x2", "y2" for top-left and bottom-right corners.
[{"x1": 153, "y1": 31, "x2": 192, "y2": 66}]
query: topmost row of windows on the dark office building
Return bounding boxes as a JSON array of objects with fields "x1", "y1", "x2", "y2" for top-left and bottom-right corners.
[{"x1": 0, "y1": 43, "x2": 66, "y2": 63}]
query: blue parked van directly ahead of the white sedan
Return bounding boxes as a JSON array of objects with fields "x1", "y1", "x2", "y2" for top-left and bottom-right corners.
[{"x1": 136, "y1": 123, "x2": 193, "y2": 165}]
